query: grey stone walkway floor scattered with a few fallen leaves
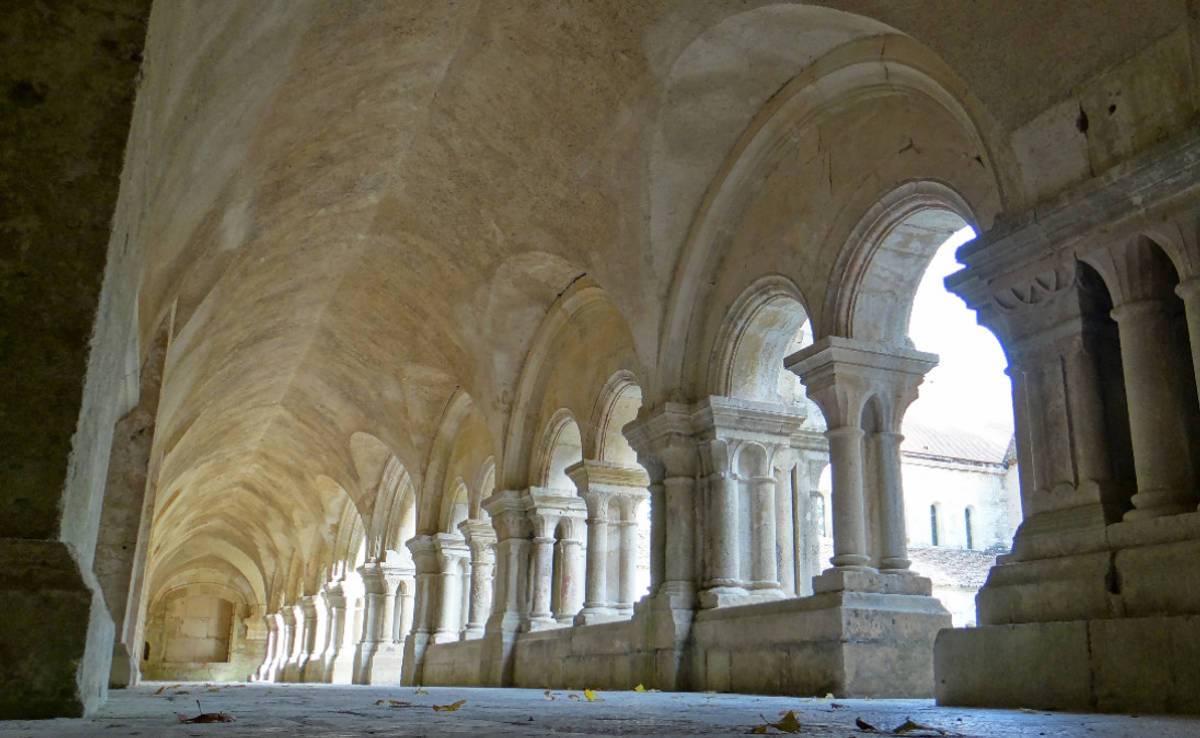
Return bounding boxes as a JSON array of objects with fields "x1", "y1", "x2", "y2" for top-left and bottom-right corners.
[{"x1": 0, "y1": 684, "x2": 1200, "y2": 738}]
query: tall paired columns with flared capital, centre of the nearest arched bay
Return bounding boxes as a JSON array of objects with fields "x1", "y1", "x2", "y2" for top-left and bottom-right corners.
[{"x1": 785, "y1": 336, "x2": 937, "y2": 592}]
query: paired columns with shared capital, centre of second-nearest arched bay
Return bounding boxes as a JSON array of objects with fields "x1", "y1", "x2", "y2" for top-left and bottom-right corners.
[{"x1": 566, "y1": 461, "x2": 650, "y2": 625}]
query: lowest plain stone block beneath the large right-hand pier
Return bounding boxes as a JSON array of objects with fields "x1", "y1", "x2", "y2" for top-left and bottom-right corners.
[{"x1": 934, "y1": 616, "x2": 1200, "y2": 714}]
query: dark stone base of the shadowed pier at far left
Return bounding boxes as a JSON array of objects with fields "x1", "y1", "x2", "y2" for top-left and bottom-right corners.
[{"x1": 0, "y1": 539, "x2": 115, "y2": 720}]
